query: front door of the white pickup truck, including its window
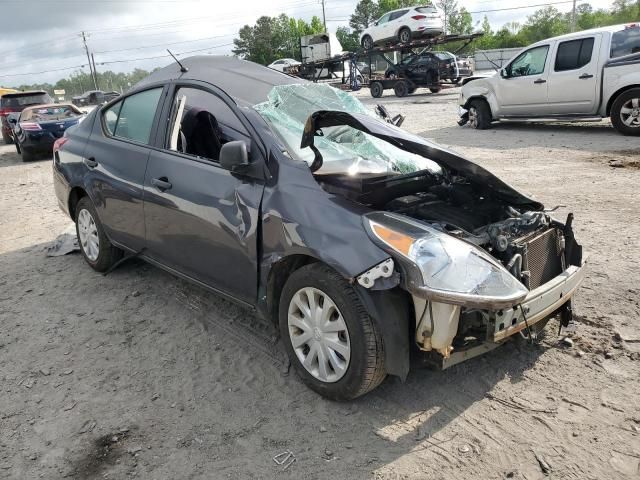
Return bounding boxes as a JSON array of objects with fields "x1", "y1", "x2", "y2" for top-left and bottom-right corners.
[{"x1": 496, "y1": 45, "x2": 550, "y2": 117}]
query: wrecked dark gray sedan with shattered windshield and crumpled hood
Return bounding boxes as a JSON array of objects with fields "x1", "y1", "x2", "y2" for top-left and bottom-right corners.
[{"x1": 53, "y1": 56, "x2": 584, "y2": 400}]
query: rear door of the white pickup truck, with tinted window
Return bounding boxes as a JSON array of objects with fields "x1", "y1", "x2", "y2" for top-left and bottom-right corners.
[{"x1": 546, "y1": 34, "x2": 602, "y2": 115}]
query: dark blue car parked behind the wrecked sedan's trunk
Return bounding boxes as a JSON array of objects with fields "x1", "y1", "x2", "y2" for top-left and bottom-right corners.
[{"x1": 9, "y1": 104, "x2": 84, "y2": 162}]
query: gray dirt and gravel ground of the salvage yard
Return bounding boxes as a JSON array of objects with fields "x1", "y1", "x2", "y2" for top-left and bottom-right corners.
[{"x1": 0, "y1": 90, "x2": 640, "y2": 480}]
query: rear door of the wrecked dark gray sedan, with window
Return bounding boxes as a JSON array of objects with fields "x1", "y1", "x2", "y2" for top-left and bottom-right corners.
[{"x1": 83, "y1": 87, "x2": 163, "y2": 252}]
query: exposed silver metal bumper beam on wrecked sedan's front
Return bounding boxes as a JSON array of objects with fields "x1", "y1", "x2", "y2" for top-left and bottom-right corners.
[{"x1": 489, "y1": 260, "x2": 586, "y2": 343}]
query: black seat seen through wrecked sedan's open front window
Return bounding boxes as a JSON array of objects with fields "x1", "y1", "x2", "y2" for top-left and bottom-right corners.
[{"x1": 181, "y1": 108, "x2": 222, "y2": 161}]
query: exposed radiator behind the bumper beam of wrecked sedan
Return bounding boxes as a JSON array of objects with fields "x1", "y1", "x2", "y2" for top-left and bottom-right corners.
[{"x1": 518, "y1": 228, "x2": 562, "y2": 290}]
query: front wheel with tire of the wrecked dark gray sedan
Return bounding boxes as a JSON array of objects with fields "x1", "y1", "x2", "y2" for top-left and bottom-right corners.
[{"x1": 279, "y1": 263, "x2": 386, "y2": 401}]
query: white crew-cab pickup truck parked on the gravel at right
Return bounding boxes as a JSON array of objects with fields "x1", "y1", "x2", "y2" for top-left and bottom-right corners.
[{"x1": 459, "y1": 23, "x2": 640, "y2": 135}]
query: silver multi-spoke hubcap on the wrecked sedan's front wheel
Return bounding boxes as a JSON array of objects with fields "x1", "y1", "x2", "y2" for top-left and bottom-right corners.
[{"x1": 288, "y1": 287, "x2": 351, "y2": 383}]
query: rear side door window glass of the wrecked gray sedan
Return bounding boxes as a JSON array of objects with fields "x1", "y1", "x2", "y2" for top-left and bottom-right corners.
[{"x1": 104, "y1": 88, "x2": 162, "y2": 145}]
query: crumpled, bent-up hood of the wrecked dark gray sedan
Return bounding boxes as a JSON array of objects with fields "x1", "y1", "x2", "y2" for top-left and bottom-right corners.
[{"x1": 300, "y1": 110, "x2": 544, "y2": 210}]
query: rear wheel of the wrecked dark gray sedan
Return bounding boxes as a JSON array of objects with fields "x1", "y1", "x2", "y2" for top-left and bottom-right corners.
[{"x1": 76, "y1": 197, "x2": 122, "y2": 272}]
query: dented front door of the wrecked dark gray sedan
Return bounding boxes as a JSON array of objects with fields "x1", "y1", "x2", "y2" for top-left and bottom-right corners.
[{"x1": 144, "y1": 87, "x2": 263, "y2": 304}]
